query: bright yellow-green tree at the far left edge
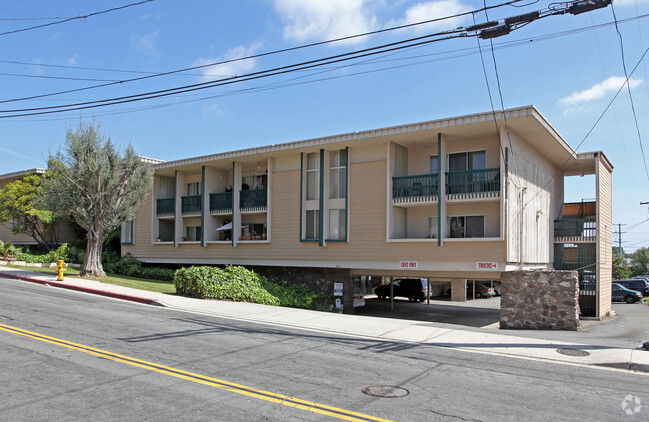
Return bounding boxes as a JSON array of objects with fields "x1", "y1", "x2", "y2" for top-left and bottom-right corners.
[{"x1": 0, "y1": 173, "x2": 60, "y2": 251}]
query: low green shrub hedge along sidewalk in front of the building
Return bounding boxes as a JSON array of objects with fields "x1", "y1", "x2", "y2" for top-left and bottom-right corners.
[{"x1": 174, "y1": 266, "x2": 332, "y2": 310}]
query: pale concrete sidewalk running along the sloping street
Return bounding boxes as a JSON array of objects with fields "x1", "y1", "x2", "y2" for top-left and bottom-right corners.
[{"x1": 0, "y1": 269, "x2": 649, "y2": 374}]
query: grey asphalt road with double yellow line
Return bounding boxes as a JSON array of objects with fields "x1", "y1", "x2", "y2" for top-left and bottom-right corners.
[{"x1": 0, "y1": 279, "x2": 649, "y2": 421}]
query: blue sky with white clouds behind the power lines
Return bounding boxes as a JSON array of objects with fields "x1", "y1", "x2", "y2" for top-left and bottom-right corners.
[{"x1": 0, "y1": 0, "x2": 649, "y2": 250}]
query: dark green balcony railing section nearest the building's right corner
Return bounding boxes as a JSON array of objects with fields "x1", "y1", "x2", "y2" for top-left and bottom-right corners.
[{"x1": 446, "y1": 167, "x2": 500, "y2": 199}]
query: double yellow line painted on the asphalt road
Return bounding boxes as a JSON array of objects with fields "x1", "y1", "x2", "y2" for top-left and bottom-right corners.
[{"x1": 0, "y1": 324, "x2": 390, "y2": 422}]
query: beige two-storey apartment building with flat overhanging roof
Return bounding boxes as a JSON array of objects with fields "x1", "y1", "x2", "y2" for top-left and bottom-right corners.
[{"x1": 122, "y1": 106, "x2": 613, "y2": 316}]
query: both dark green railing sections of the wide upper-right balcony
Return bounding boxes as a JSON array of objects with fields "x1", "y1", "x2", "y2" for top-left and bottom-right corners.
[{"x1": 392, "y1": 167, "x2": 500, "y2": 206}]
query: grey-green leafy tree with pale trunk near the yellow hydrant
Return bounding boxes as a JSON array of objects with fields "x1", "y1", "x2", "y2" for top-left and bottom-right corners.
[{"x1": 43, "y1": 121, "x2": 153, "y2": 277}]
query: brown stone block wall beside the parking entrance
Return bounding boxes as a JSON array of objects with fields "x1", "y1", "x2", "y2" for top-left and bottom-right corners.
[{"x1": 500, "y1": 270, "x2": 579, "y2": 330}]
